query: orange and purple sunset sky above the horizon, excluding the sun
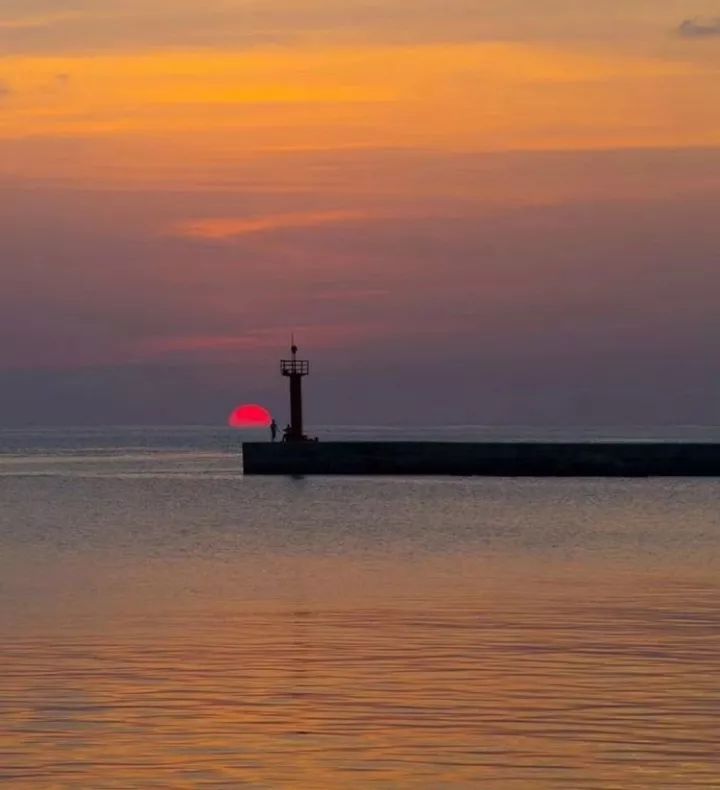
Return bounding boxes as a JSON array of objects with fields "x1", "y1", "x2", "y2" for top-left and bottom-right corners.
[{"x1": 0, "y1": 0, "x2": 720, "y2": 427}]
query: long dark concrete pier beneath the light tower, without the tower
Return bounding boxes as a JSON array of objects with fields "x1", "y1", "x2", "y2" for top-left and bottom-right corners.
[{"x1": 243, "y1": 442, "x2": 720, "y2": 477}]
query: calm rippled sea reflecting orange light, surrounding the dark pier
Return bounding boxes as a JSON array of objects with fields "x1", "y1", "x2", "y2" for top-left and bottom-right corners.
[{"x1": 0, "y1": 426, "x2": 720, "y2": 790}]
